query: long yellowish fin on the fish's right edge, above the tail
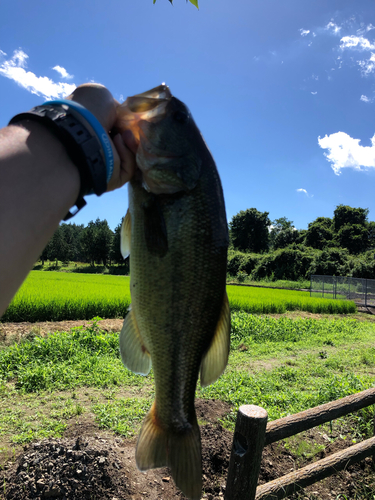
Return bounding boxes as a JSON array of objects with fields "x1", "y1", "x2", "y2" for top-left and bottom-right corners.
[{"x1": 201, "y1": 293, "x2": 230, "y2": 387}]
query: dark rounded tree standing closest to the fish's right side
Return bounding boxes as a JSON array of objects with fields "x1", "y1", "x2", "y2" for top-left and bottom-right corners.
[{"x1": 229, "y1": 208, "x2": 271, "y2": 253}]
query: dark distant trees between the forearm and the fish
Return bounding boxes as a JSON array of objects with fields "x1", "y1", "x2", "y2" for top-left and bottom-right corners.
[{"x1": 39, "y1": 218, "x2": 124, "y2": 266}]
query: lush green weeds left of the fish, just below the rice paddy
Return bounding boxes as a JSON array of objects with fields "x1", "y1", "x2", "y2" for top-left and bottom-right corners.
[{"x1": 0, "y1": 321, "x2": 146, "y2": 393}]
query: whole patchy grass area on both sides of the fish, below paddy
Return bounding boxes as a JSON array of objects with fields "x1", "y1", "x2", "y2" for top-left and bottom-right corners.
[{"x1": 0, "y1": 312, "x2": 375, "y2": 459}]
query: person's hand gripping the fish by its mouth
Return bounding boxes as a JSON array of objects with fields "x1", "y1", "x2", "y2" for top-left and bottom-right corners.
[{"x1": 66, "y1": 83, "x2": 135, "y2": 191}]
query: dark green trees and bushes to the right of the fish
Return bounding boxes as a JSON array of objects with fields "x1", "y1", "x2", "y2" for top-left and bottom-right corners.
[{"x1": 228, "y1": 205, "x2": 375, "y2": 280}]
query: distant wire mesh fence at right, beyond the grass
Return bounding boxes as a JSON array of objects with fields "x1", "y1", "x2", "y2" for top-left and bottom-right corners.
[{"x1": 310, "y1": 275, "x2": 375, "y2": 307}]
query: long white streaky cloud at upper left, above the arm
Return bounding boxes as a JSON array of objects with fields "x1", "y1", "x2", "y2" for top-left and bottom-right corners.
[{"x1": 0, "y1": 49, "x2": 76, "y2": 100}]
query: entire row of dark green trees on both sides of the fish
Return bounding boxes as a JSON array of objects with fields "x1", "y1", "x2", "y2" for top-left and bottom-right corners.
[{"x1": 40, "y1": 205, "x2": 375, "y2": 280}]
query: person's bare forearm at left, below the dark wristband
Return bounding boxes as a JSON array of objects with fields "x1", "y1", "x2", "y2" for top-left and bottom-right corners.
[{"x1": 0, "y1": 122, "x2": 80, "y2": 316}]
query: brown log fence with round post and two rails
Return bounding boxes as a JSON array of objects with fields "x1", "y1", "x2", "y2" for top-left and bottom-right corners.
[{"x1": 225, "y1": 388, "x2": 375, "y2": 500}]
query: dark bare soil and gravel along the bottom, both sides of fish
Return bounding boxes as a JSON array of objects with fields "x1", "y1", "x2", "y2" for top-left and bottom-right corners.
[{"x1": 0, "y1": 400, "x2": 375, "y2": 500}]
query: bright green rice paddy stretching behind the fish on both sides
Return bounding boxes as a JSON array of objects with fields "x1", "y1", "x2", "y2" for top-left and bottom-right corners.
[{"x1": 1, "y1": 271, "x2": 356, "y2": 322}]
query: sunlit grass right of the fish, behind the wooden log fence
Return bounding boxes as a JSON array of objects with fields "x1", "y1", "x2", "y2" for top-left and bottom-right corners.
[{"x1": 201, "y1": 313, "x2": 375, "y2": 428}]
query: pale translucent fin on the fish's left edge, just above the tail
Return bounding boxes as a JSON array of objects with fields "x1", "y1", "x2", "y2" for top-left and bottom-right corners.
[{"x1": 120, "y1": 310, "x2": 151, "y2": 375}]
